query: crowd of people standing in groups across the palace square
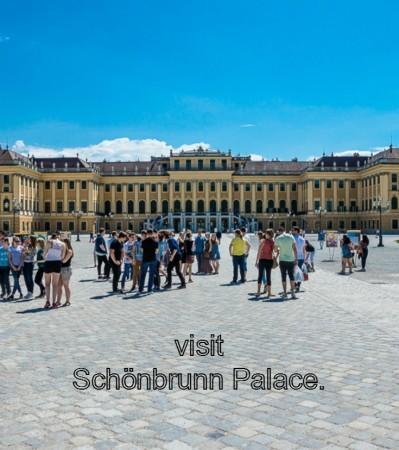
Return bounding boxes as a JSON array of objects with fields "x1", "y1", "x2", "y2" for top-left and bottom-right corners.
[{"x1": 0, "y1": 226, "x2": 369, "y2": 308}]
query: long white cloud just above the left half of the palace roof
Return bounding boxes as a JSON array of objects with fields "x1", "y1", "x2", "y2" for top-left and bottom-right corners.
[{"x1": 12, "y1": 138, "x2": 217, "y2": 161}]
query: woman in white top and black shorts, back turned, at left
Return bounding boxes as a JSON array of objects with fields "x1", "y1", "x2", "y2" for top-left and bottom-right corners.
[{"x1": 44, "y1": 233, "x2": 66, "y2": 308}]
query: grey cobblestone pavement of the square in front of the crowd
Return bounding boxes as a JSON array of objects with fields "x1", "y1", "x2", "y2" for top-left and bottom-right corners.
[{"x1": 0, "y1": 236, "x2": 399, "y2": 450}]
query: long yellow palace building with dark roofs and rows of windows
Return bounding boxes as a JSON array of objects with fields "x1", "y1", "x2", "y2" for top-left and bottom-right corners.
[{"x1": 0, "y1": 146, "x2": 399, "y2": 233}]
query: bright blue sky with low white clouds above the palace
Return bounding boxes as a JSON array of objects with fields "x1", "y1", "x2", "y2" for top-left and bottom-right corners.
[{"x1": 0, "y1": 0, "x2": 399, "y2": 159}]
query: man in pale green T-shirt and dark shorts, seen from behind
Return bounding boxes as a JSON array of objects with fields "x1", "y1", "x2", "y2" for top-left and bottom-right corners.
[{"x1": 274, "y1": 225, "x2": 298, "y2": 299}]
